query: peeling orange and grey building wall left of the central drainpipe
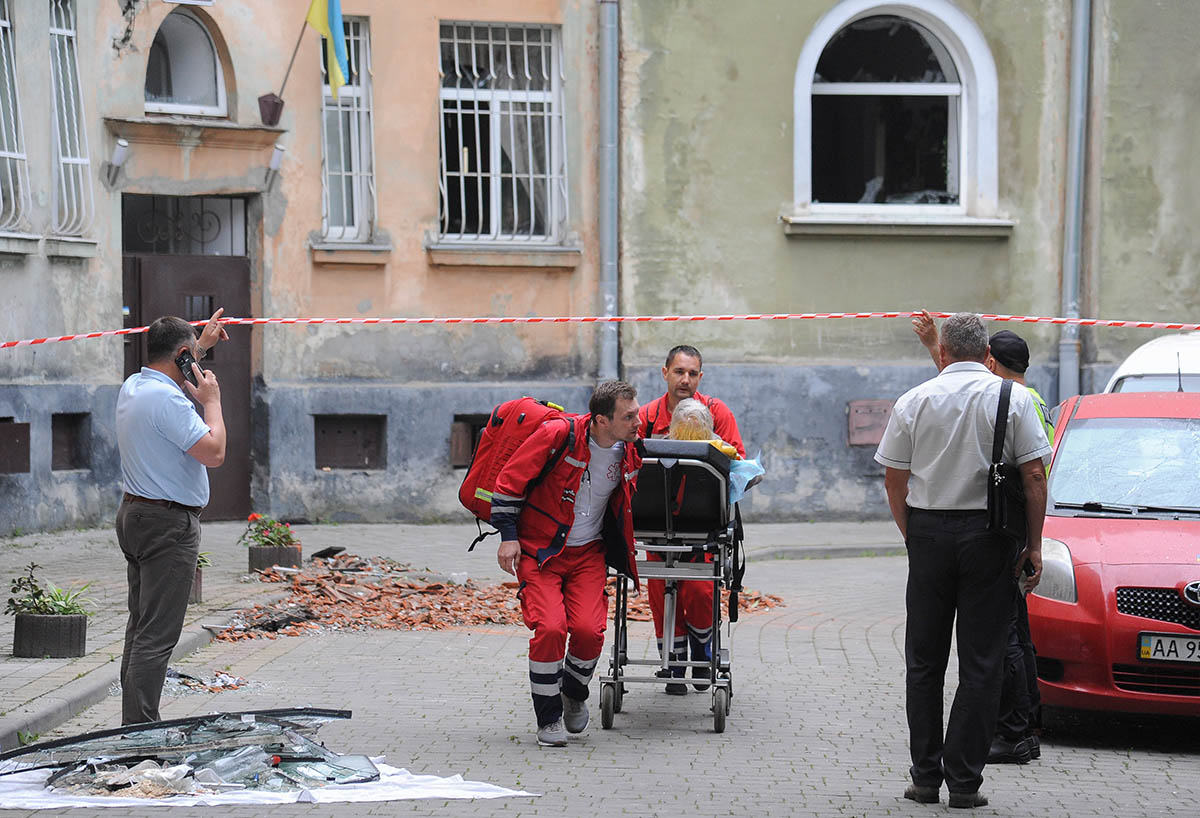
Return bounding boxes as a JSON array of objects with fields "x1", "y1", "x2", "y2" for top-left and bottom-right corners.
[{"x1": 0, "y1": 0, "x2": 600, "y2": 534}]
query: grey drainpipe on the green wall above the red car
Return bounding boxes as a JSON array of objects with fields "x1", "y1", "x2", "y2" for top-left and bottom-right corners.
[{"x1": 1058, "y1": 0, "x2": 1092, "y2": 402}]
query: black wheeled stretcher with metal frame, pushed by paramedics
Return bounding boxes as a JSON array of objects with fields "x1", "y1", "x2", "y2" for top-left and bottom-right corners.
[{"x1": 600, "y1": 439, "x2": 745, "y2": 733}]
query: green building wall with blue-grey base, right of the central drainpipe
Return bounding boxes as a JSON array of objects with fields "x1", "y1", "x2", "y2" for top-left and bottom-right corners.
[{"x1": 622, "y1": 0, "x2": 1200, "y2": 519}]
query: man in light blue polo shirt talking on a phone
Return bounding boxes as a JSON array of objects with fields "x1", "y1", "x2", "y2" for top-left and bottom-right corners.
[{"x1": 116, "y1": 309, "x2": 229, "y2": 724}]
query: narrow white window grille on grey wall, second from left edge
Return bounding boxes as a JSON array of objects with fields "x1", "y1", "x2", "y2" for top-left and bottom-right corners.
[{"x1": 50, "y1": 0, "x2": 94, "y2": 235}]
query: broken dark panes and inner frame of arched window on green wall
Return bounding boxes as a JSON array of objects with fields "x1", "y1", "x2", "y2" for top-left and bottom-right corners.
[{"x1": 812, "y1": 14, "x2": 962, "y2": 205}]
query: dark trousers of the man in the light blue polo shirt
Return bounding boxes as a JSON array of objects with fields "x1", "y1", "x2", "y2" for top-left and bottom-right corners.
[{"x1": 116, "y1": 500, "x2": 200, "y2": 724}]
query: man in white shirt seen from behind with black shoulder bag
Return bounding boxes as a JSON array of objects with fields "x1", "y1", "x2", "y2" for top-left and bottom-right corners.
[{"x1": 875, "y1": 313, "x2": 1051, "y2": 807}]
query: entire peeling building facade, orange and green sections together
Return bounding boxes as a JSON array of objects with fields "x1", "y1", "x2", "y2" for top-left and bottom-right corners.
[{"x1": 7, "y1": 0, "x2": 1200, "y2": 535}]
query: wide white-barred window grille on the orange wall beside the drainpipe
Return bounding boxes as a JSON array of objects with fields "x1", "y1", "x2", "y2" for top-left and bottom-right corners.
[{"x1": 438, "y1": 23, "x2": 570, "y2": 243}]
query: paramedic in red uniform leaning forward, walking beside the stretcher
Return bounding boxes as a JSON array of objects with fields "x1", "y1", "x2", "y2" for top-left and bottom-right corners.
[{"x1": 491, "y1": 380, "x2": 642, "y2": 747}]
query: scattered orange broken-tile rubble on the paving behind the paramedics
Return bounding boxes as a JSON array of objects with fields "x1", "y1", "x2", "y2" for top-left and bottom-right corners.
[{"x1": 216, "y1": 554, "x2": 784, "y2": 642}]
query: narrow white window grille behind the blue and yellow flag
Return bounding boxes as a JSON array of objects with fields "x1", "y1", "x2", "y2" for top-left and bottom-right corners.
[{"x1": 320, "y1": 18, "x2": 376, "y2": 241}]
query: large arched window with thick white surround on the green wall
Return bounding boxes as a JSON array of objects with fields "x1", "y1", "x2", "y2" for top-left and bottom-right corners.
[{"x1": 793, "y1": 0, "x2": 997, "y2": 218}]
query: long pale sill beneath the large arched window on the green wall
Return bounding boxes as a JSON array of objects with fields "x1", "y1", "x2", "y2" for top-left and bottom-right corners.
[{"x1": 780, "y1": 212, "x2": 1016, "y2": 239}]
